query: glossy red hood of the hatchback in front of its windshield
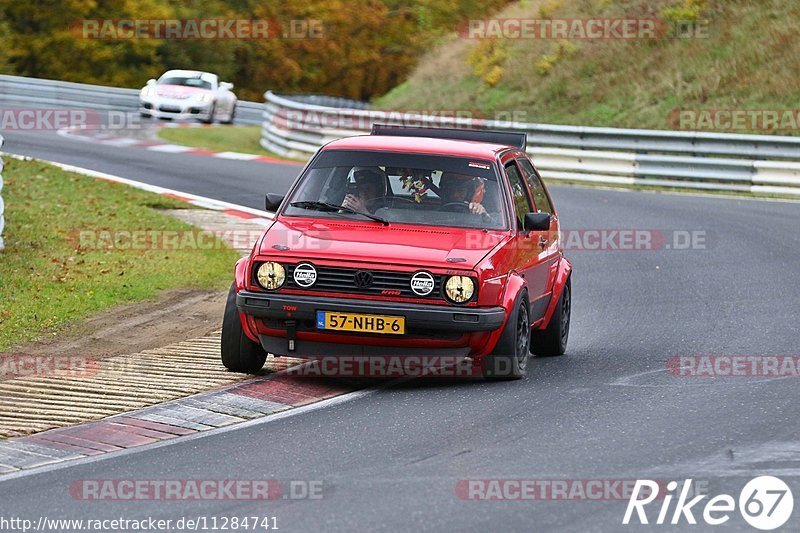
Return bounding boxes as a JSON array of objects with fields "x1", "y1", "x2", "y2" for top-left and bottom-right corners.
[{"x1": 259, "y1": 217, "x2": 507, "y2": 269}]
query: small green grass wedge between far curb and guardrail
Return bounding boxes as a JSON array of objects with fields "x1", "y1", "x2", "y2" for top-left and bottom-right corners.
[{"x1": 158, "y1": 126, "x2": 292, "y2": 159}]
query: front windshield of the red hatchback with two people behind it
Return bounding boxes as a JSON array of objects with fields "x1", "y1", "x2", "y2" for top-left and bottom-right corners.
[{"x1": 283, "y1": 150, "x2": 507, "y2": 229}]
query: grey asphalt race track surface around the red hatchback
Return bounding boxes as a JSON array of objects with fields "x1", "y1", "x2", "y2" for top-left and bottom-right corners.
[{"x1": 0, "y1": 133, "x2": 800, "y2": 531}]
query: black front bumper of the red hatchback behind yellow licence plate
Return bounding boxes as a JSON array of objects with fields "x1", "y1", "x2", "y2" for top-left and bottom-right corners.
[{"x1": 236, "y1": 291, "x2": 506, "y2": 333}]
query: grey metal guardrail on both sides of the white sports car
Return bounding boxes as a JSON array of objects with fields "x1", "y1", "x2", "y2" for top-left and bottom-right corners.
[{"x1": 0, "y1": 74, "x2": 264, "y2": 125}]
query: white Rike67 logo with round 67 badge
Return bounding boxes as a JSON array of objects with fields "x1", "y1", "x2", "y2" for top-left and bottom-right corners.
[{"x1": 622, "y1": 476, "x2": 794, "y2": 531}]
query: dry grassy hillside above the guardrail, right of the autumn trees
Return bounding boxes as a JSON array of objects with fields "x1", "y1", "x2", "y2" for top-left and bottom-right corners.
[{"x1": 375, "y1": 0, "x2": 800, "y2": 134}]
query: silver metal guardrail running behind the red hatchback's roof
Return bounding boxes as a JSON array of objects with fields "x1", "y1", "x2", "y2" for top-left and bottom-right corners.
[{"x1": 261, "y1": 91, "x2": 800, "y2": 195}]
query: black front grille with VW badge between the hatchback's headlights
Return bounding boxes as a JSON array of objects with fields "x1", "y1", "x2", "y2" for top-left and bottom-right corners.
[{"x1": 285, "y1": 265, "x2": 442, "y2": 299}]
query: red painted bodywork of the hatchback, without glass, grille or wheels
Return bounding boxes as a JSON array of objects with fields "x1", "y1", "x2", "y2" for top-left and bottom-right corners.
[{"x1": 235, "y1": 131, "x2": 572, "y2": 358}]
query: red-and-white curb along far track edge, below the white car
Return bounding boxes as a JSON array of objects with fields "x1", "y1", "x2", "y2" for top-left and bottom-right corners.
[{"x1": 57, "y1": 124, "x2": 303, "y2": 165}]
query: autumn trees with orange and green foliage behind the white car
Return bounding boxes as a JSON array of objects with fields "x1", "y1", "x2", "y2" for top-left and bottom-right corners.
[{"x1": 0, "y1": 0, "x2": 508, "y2": 100}]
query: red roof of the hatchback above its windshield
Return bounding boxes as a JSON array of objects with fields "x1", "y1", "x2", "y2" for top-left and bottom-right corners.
[{"x1": 324, "y1": 135, "x2": 513, "y2": 159}]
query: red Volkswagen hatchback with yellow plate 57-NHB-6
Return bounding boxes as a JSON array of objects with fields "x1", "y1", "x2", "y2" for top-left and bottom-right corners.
[{"x1": 222, "y1": 125, "x2": 572, "y2": 379}]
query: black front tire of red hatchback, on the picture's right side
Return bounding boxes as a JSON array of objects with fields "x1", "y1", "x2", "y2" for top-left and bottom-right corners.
[{"x1": 483, "y1": 292, "x2": 531, "y2": 380}]
